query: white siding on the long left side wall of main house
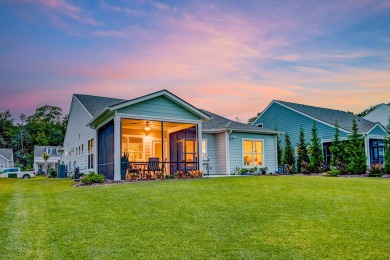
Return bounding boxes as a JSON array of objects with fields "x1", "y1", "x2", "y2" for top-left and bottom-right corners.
[{"x1": 61, "y1": 96, "x2": 96, "y2": 172}]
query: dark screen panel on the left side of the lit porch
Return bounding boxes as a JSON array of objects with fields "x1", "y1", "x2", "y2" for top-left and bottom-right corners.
[{"x1": 97, "y1": 121, "x2": 114, "y2": 180}]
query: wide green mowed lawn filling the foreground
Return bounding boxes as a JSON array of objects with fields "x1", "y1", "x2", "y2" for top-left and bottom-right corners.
[{"x1": 0, "y1": 176, "x2": 390, "y2": 259}]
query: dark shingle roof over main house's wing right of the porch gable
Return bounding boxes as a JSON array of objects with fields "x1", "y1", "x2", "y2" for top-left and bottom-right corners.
[{"x1": 201, "y1": 109, "x2": 278, "y2": 134}]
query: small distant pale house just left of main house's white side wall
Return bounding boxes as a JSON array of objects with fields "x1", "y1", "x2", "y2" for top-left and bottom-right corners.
[{"x1": 34, "y1": 145, "x2": 62, "y2": 174}]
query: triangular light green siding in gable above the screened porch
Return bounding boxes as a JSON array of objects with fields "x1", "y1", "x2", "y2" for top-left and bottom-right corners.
[{"x1": 117, "y1": 96, "x2": 201, "y2": 120}]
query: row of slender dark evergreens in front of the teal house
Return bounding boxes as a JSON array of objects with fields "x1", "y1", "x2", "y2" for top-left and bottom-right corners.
[{"x1": 277, "y1": 119, "x2": 390, "y2": 175}]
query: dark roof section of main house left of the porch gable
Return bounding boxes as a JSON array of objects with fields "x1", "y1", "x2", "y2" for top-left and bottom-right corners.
[{"x1": 74, "y1": 94, "x2": 126, "y2": 117}]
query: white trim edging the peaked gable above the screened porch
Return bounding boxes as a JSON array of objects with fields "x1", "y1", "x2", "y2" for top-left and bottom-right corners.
[{"x1": 109, "y1": 89, "x2": 211, "y2": 120}]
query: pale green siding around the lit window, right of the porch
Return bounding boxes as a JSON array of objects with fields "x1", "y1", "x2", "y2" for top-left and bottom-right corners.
[{"x1": 229, "y1": 132, "x2": 277, "y2": 172}]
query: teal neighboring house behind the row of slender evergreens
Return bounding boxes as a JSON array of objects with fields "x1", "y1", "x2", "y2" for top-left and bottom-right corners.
[{"x1": 253, "y1": 100, "x2": 386, "y2": 165}]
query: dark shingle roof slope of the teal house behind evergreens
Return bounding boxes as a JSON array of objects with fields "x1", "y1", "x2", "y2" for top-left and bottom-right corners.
[{"x1": 275, "y1": 100, "x2": 375, "y2": 133}]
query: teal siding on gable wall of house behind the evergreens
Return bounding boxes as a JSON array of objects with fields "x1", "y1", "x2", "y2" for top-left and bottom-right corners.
[{"x1": 254, "y1": 103, "x2": 347, "y2": 147}]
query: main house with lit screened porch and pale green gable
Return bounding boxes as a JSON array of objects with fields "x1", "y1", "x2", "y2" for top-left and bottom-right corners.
[{"x1": 61, "y1": 90, "x2": 278, "y2": 180}]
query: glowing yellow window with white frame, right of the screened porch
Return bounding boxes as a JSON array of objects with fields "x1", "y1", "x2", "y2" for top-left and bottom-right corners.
[{"x1": 243, "y1": 140, "x2": 263, "y2": 167}]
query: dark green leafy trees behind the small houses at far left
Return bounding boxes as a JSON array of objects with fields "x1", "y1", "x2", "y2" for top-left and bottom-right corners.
[{"x1": 0, "y1": 105, "x2": 68, "y2": 169}]
